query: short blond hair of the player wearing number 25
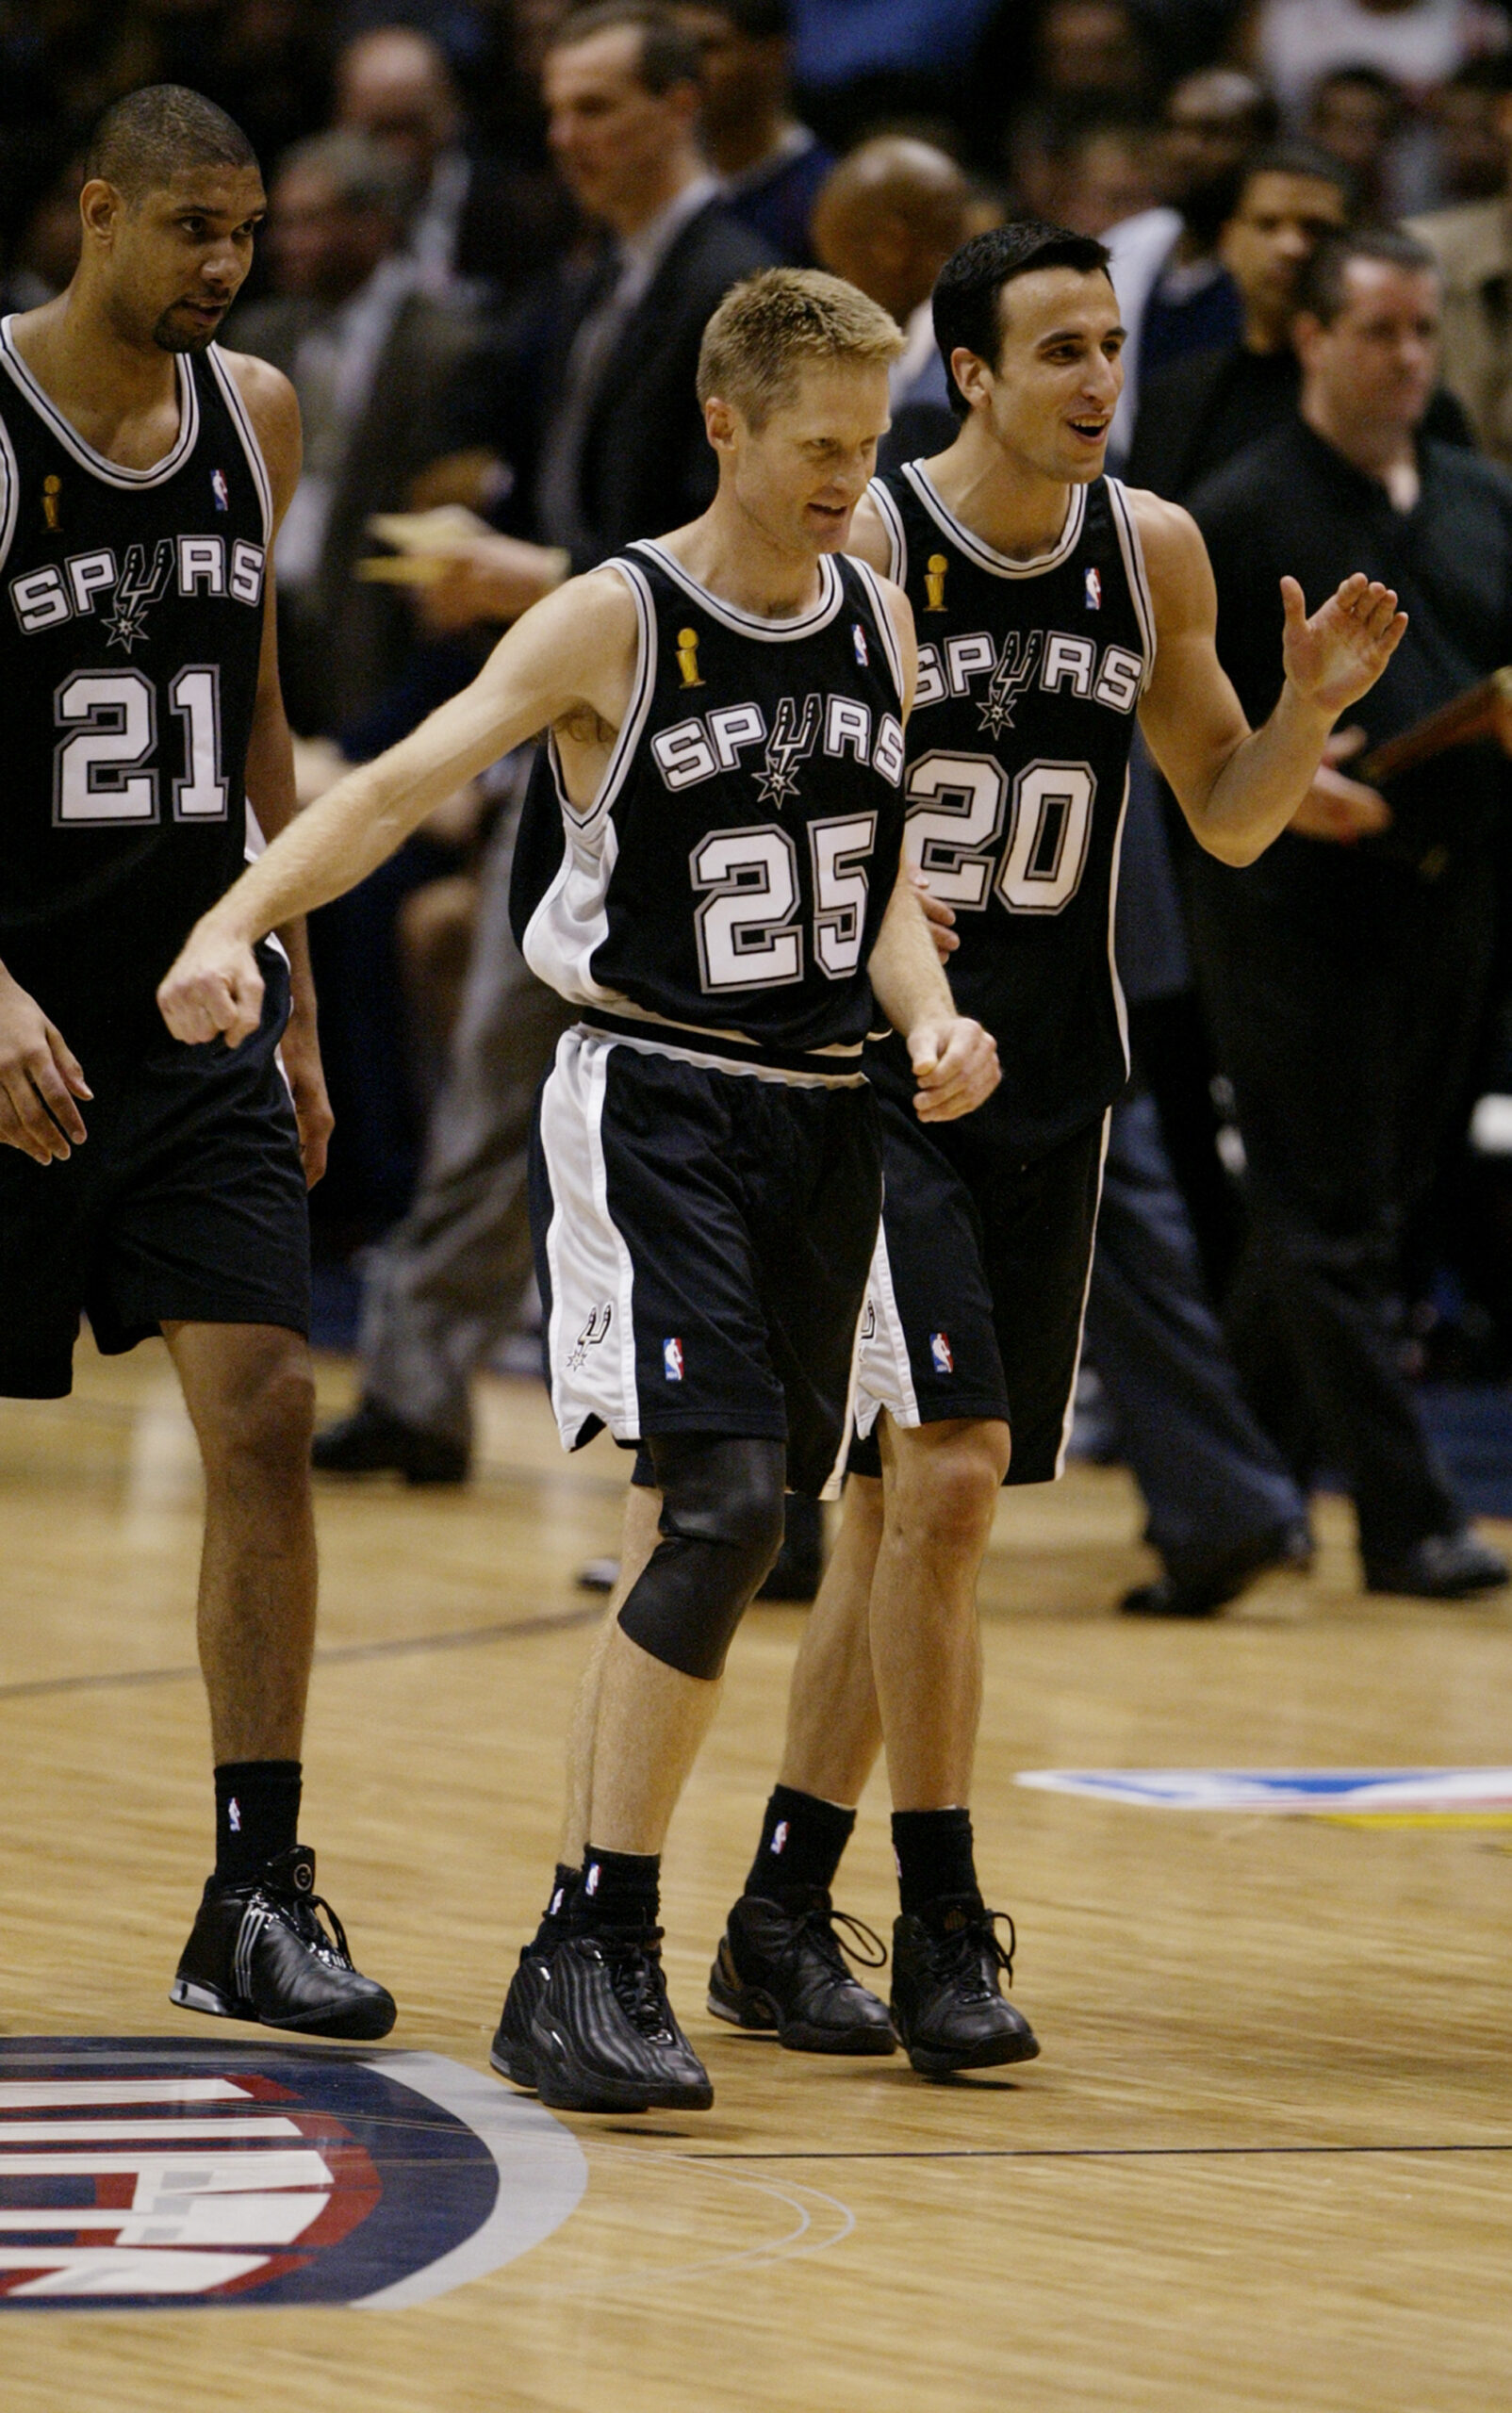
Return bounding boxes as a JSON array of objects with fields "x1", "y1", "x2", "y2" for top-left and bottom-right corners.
[{"x1": 697, "y1": 268, "x2": 904, "y2": 430}]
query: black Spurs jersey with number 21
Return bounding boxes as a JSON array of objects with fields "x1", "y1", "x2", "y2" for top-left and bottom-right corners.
[{"x1": 0, "y1": 320, "x2": 272, "y2": 1061}]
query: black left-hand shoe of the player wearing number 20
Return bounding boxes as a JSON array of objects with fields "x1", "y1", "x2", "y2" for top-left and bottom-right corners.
[{"x1": 709, "y1": 1884, "x2": 897, "y2": 2054}]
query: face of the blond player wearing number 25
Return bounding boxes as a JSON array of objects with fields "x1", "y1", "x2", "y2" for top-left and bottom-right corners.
[{"x1": 704, "y1": 362, "x2": 887, "y2": 555}]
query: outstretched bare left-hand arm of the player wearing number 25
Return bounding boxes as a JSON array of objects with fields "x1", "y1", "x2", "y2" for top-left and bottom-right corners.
[{"x1": 156, "y1": 569, "x2": 636, "y2": 1047}]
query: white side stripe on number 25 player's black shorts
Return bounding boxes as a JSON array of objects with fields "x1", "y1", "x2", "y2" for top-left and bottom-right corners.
[{"x1": 540, "y1": 1030, "x2": 641, "y2": 1451}]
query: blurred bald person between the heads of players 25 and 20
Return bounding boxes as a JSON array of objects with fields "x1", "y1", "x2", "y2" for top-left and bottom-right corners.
[{"x1": 813, "y1": 135, "x2": 972, "y2": 468}]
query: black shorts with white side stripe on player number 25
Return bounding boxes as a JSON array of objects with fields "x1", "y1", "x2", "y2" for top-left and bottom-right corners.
[{"x1": 531, "y1": 1028, "x2": 882, "y2": 1499}]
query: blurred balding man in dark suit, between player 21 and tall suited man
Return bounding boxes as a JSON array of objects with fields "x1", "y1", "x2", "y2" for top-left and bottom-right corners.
[{"x1": 336, "y1": 25, "x2": 574, "y2": 302}]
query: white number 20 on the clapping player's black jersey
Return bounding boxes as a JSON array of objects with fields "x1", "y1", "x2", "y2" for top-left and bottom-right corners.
[{"x1": 904, "y1": 753, "x2": 1097, "y2": 912}]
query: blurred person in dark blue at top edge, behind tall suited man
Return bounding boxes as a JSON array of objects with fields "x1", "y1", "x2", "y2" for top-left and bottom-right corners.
[{"x1": 673, "y1": 0, "x2": 834, "y2": 268}]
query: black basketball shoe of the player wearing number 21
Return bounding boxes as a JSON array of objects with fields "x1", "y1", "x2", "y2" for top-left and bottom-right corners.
[{"x1": 172, "y1": 1844, "x2": 398, "y2": 2042}]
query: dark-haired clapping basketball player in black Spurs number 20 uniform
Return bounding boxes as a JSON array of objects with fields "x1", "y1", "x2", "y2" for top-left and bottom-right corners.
[{"x1": 709, "y1": 222, "x2": 1405, "y2": 2077}]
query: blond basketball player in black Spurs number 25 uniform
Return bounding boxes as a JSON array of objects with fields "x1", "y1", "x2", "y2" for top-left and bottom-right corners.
[{"x1": 159, "y1": 271, "x2": 996, "y2": 2111}]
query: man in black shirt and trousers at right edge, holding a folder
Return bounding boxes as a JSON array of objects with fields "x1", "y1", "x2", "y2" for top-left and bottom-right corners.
[{"x1": 1192, "y1": 232, "x2": 1512, "y2": 1600}]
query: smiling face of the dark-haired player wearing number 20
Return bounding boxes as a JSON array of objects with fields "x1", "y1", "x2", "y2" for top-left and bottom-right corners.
[{"x1": 952, "y1": 268, "x2": 1124, "y2": 485}]
